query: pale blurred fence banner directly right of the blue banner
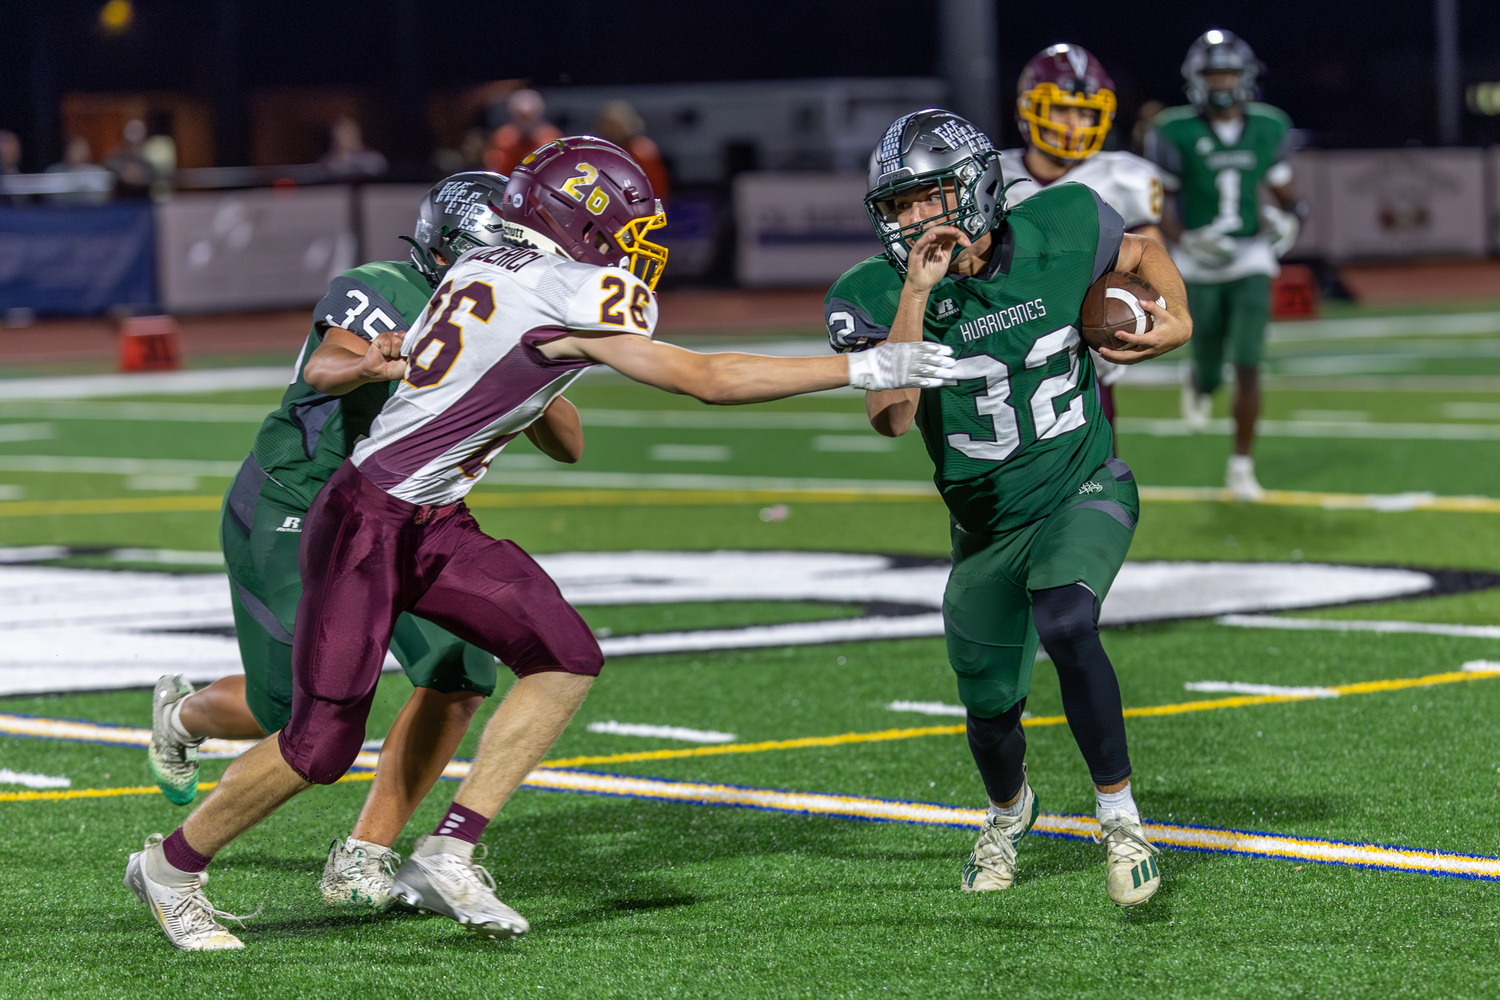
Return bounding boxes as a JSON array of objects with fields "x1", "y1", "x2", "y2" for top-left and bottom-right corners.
[{"x1": 156, "y1": 187, "x2": 356, "y2": 312}]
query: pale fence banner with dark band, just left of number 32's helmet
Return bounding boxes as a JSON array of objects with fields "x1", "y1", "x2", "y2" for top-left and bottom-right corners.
[{"x1": 735, "y1": 174, "x2": 881, "y2": 288}]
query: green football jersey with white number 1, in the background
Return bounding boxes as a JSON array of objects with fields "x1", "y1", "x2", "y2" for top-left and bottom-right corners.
[{"x1": 1146, "y1": 102, "x2": 1292, "y2": 237}]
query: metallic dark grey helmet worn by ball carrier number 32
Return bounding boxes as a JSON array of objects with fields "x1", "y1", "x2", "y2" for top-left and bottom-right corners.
[{"x1": 864, "y1": 108, "x2": 1005, "y2": 274}]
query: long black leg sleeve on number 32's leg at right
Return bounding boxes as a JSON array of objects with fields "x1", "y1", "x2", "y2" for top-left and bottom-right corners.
[{"x1": 1032, "y1": 583, "x2": 1130, "y2": 784}]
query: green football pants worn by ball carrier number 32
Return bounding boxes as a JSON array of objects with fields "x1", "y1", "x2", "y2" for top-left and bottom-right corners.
[{"x1": 942, "y1": 459, "x2": 1140, "y2": 718}]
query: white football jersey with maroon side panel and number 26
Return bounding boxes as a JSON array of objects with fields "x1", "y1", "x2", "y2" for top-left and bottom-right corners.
[{"x1": 351, "y1": 246, "x2": 657, "y2": 505}]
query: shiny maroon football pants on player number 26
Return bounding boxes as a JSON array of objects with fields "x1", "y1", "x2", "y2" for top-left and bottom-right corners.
[{"x1": 279, "y1": 462, "x2": 605, "y2": 784}]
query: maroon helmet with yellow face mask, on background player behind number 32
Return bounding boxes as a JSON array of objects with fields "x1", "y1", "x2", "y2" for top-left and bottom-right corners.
[{"x1": 1016, "y1": 45, "x2": 1118, "y2": 160}]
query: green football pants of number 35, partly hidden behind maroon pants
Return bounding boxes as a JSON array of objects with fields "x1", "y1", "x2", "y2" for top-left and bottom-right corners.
[{"x1": 219, "y1": 460, "x2": 497, "y2": 733}]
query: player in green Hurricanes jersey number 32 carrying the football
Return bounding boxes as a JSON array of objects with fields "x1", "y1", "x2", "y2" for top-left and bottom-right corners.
[{"x1": 825, "y1": 109, "x2": 1193, "y2": 906}]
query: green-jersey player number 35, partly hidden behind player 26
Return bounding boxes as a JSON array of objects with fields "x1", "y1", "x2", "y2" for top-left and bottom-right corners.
[{"x1": 150, "y1": 171, "x2": 582, "y2": 909}]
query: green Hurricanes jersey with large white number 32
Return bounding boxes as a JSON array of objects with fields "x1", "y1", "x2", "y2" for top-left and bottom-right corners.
[{"x1": 824, "y1": 183, "x2": 1125, "y2": 534}]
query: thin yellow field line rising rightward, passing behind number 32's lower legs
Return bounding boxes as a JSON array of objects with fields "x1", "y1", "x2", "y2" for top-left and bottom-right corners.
[{"x1": 0, "y1": 670, "x2": 1500, "y2": 802}]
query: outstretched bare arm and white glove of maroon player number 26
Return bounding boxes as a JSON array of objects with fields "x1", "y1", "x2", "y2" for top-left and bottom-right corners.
[{"x1": 539, "y1": 333, "x2": 953, "y2": 405}]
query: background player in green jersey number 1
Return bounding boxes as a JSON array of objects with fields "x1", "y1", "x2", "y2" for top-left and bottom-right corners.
[{"x1": 1146, "y1": 30, "x2": 1307, "y2": 501}]
